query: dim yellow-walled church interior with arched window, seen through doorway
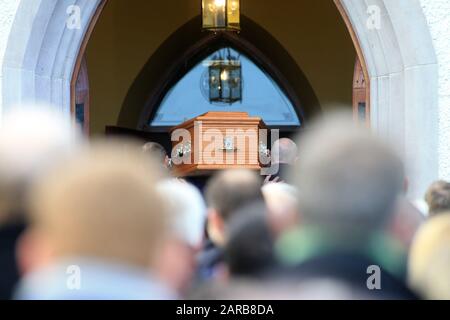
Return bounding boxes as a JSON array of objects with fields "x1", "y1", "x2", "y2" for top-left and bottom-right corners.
[{"x1": 76, "y1": 0, "x2": 357, "y2": 135}]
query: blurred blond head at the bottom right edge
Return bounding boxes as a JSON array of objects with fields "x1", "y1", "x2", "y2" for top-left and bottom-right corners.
[{"x1": 408, "y1": 214, "x2": 450, "y2": 299}]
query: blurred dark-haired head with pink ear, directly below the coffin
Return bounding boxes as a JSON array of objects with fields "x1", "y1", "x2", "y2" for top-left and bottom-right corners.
[{"x1": 206, "y1": 170, "x2": 263, "y2": 246}]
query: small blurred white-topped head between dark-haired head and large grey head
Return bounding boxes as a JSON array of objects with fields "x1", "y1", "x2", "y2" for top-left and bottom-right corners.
[{"x1": 262, "y1": 183, "x2": 298, "y2": 234}]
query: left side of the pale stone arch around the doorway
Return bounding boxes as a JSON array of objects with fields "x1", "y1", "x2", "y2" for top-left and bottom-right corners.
[{"x1": 2, "y1": 0, "x2": 104, "y2": 117}]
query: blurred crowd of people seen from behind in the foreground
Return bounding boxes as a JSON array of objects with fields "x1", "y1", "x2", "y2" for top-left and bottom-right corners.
[{"x1": 0, "y1": 108, "x2": 450, "y2": 300}]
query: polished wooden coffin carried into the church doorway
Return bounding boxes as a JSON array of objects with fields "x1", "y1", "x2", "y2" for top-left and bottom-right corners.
[{"x1": 171, "y1": 112, "x2": 267, "y2": 176}]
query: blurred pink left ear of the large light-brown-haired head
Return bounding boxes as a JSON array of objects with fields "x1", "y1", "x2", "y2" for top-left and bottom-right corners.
[{"x1": 16, "y1": 230, "x2": 53, "y2": 275}]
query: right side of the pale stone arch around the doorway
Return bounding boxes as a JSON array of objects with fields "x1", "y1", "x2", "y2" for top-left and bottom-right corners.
[{"x1": 335, "y1": 0, "x2": 439, "y2": 198}]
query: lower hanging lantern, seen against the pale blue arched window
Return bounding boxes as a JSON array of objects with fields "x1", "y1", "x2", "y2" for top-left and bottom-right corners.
[{"x1": 209, "y1": 49, "x2": 242, "y2": 104}]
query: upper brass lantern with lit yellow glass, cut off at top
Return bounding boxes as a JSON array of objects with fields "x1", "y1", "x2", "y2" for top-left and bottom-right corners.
[{"x1": 202, "y1": 0, "x2": 241, "y2": 31}]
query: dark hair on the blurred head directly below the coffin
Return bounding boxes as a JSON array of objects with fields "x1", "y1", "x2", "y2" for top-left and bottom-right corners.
[{"x1": 206, "y1": 170, "x2": 263, "y2": 222}]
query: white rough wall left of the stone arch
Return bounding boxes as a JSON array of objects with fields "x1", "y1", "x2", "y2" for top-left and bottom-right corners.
[{"x1": 0, "y1": 0, "x2": 20, "y2": 120}]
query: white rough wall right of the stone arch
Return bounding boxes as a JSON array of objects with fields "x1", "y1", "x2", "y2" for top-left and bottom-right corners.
[{"x1": 420, "y1": 0, "x2": 450, "y2": 180}]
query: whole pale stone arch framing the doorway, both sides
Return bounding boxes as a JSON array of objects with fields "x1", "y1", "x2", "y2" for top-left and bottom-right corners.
[{"x1": 2, "y1": 0, "x2": 439, "y2": 197}]
